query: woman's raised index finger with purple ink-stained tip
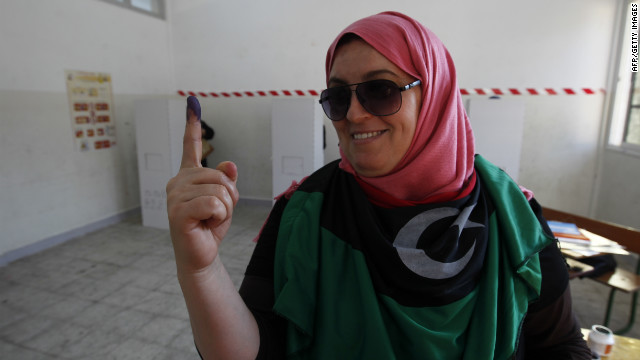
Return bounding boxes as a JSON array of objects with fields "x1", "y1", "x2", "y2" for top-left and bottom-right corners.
[{"x1": 180, "y1": 96, "x2": 202, "y2": 169}]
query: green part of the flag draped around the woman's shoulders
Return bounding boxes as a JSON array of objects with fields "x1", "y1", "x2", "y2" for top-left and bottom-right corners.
[{"x1": 274, "y1": 157, "x2": 552, "y2": 359}]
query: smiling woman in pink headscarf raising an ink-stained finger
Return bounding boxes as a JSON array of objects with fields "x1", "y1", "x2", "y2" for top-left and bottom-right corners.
[{"x1": 167, "y1": 12, "x2": 590, "y2": 359}]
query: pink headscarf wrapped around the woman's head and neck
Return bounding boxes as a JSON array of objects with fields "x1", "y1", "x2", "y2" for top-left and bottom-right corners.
[{"x1": 326, "y1": 12, "x2": 475, "y2": 205}]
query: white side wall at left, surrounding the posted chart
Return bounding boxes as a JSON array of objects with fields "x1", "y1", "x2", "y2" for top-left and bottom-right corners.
[{"x1": 0, "y1": 0, "x2": 174, "y2": 257}]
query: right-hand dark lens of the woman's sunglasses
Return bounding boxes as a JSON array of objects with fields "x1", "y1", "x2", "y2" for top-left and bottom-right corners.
[{"x1": 356, "y1": 80, "x2": 402, "y2": 116}]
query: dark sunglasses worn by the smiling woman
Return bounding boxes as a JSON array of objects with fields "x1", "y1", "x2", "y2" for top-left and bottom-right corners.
[{"x1": 320, "y1": 80, "x2": 420, "y2": 121}]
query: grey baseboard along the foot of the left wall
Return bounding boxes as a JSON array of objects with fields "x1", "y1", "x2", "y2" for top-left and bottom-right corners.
[{"x1": 0, "y1": 207, "x2": 140, "y2": 266}]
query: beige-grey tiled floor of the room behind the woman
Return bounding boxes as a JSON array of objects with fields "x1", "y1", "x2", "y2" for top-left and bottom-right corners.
[{"x1": 0, "y1": 203, "x2": 640, "y2": 360}]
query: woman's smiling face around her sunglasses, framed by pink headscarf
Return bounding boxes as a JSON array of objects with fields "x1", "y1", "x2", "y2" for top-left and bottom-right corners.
[{"x1": 328, "y1": 39, "x2": 422, "y2": 177}]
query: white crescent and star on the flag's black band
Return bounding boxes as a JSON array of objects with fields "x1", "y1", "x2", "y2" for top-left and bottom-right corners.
[{"x1": 393, "y1": 204, "x2": 484, "y2": 279}]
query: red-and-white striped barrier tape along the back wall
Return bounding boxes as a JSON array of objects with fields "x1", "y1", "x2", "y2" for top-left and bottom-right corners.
[{"x1": 178, "y1": 88, "x2": 606, "y2": 98}]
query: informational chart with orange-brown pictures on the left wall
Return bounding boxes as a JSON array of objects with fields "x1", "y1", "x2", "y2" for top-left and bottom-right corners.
[{"x1": 65, "y1": 70, "x2": 116, "y2": 151}]
